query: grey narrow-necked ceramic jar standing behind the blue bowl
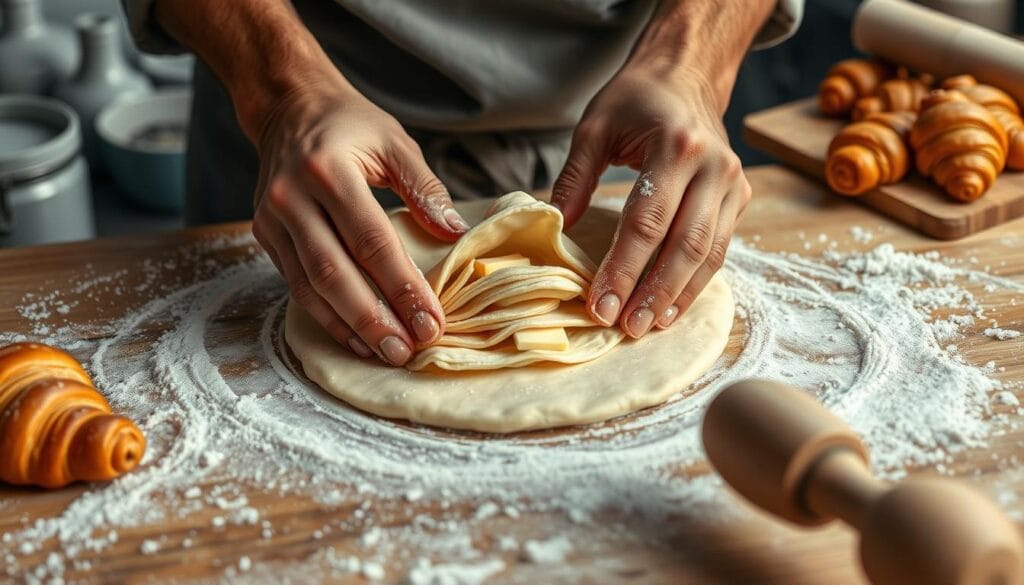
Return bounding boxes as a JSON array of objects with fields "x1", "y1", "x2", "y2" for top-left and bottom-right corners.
[{"x1": 53, "y1": 13, "x2": 153, "y2": 170}]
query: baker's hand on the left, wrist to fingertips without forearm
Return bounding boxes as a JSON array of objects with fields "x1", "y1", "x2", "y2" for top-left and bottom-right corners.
[{"x1": 253, "y1": 75, "x2": 469, "y2": 366}]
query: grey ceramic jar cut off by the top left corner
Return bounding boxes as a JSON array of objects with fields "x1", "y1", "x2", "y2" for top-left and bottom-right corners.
[{"x1": 0, "y1": 0, "x2": 79, "y2": 94}]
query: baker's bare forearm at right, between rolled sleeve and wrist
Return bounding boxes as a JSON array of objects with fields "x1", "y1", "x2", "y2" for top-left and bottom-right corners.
[{"x1": 624, "y1": 0, "x2": 776, "y2": 114}]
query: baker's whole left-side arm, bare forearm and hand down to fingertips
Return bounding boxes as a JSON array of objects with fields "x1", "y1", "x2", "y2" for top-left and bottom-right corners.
[{"x1": 154, "y1": 0, "x2": 468, "y2": 366}]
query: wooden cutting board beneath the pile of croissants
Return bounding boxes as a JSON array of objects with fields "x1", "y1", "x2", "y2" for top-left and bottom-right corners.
[{"x1": 743, "y1": 97, "x2": 1024, "y2": 240}]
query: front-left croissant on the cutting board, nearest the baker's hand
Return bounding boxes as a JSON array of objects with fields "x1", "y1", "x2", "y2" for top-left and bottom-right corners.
[{"x1": 825, "y1": 112, "x2": 918, "y2": 196}]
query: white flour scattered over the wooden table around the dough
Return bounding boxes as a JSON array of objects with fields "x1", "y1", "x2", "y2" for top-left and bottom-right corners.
[{"x1": 0, "y1": 223, "x2": 1022, "y2": 585}]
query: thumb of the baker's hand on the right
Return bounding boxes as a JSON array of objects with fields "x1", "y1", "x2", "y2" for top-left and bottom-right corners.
[{"x1": 551, "y1": 122, "x2": 608, "y2": 227}]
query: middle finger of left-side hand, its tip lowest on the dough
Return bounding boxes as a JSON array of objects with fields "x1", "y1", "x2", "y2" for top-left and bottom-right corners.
[{"x1": 267, "y1": 179, "x2": 414, "y2": 366}]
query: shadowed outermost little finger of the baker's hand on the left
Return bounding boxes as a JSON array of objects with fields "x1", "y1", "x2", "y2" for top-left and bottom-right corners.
[{"x1": 253, "y1": 214, "x2": 374, "y2": 358}]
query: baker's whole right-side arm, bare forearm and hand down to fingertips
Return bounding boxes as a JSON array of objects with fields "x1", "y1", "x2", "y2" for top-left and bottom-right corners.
[{"x1": 552, "y1": 0, "x2": 774, "y2": 338}]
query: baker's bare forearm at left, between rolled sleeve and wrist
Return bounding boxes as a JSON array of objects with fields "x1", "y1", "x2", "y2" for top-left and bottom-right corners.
[{"x1": 153, "y1": 0, "x2": 350, "y2": 142}]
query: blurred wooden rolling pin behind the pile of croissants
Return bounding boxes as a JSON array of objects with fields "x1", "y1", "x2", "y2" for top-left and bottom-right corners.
[{"x1": 853, "y1": 0, "x2": 1024, "y2": 103}]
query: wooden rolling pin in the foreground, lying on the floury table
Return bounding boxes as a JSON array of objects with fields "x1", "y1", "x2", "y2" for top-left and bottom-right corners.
[{"x1": 701, "y1": 380, "x2": 1024, "y2": 585}]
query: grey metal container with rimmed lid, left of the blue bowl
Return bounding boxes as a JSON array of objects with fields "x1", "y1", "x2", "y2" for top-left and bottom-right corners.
[{"x1": 0, "y1": 95, "x2": 95, "y2": 247}]
